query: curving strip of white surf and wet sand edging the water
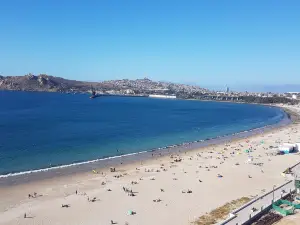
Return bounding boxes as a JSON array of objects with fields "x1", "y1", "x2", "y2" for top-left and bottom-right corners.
[{"x1": 0, "y1": 105, "x2": 292, "y2": 187}]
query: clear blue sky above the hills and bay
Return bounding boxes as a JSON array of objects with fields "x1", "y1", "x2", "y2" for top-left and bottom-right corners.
[{"x1": 0, "y1": 0, "x2": 300, "y2": 89}]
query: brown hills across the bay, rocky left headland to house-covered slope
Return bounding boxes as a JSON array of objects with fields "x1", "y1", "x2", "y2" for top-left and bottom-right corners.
[{"x1": 0, "y1": 74, "x2": 208, "y2": 94}]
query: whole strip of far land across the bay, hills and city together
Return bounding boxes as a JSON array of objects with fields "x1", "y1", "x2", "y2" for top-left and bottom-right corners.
[{"x1": 0, "y1": 74, "x2": 300, "y2": 104}]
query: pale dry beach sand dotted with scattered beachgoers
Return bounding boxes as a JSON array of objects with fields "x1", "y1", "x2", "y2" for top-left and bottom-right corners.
[{"x1": 0, "y1": 107, "x2": 300, "y2": 225}]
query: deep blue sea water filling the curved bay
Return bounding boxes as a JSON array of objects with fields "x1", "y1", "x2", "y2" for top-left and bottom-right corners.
[{"x1": 0, "y1": 92, "x2": 284, "y2": 175}]
